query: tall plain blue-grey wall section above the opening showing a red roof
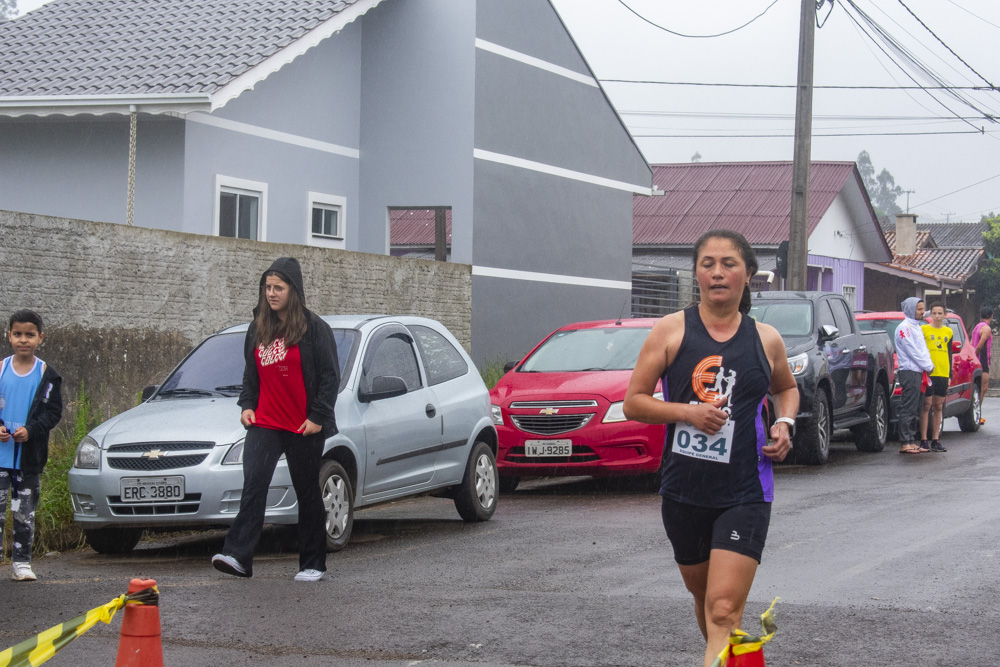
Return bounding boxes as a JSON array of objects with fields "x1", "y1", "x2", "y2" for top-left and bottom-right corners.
[{"x1": 358, "y1": 0, "x2": 475, "y2": 263}]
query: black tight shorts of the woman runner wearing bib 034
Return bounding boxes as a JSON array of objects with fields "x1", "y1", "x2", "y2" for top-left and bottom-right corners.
[{"x1": 662, "y1": 498, "x2": 771, "y2": 565}]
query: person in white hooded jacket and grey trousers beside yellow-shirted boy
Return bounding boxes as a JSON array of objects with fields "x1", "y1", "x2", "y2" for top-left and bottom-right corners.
[{"x1": 894, "y1": 296, "x2": 934, "y2": 454}]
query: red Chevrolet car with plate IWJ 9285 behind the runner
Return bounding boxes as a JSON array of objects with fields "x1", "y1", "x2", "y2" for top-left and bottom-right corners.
[{"x1": 490, "y1": 318, "x2": 666, "y2": 490}]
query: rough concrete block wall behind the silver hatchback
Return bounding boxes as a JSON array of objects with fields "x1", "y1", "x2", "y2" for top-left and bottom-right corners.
[{"x1": 0, "y1": 211, "x2": 472, "y2": 417}]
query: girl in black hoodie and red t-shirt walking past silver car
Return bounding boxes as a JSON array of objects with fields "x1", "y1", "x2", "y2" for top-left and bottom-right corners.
[{"x1": 212, "y1": 257, "x2": 340, "y2": 581}]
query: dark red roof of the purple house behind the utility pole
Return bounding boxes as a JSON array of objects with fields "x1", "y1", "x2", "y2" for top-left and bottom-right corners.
[{"x1": 632, "y1": 162, "x2": 856, "y2": 246}]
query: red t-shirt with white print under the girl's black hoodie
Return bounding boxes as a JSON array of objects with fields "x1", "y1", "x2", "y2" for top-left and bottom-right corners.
[{"x1": 255, "y1": 338, "x2": 307, "y2": 433}]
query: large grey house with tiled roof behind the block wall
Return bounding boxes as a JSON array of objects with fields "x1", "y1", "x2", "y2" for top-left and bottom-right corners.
[{"x1": 0, "y1": 0, "x2": 652, "y2": 361}]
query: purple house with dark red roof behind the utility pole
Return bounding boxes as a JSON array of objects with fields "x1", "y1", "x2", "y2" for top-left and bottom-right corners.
[{"x1": 632, "y1": 162, "x2": 892, "y2": 316}]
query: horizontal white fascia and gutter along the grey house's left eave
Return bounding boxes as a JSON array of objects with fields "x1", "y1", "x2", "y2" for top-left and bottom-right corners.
[{"x1": 0, "y1": 93, "x2": 211, "y2": 118}]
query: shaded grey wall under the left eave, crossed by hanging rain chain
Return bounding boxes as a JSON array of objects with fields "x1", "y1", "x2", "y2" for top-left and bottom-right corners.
[{"x1": 0, "y1": 116, "x2": 184, "y2": 229}]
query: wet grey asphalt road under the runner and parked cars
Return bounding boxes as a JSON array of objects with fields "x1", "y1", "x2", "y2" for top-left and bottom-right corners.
[{"x1": 0, "y1": 398, "x2": 1000, "y2": 667}]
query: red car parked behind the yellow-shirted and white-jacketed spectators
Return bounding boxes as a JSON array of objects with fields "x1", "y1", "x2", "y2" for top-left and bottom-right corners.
[{"x1": 855, "y1": 311, "x2": 983, "y2": 431}]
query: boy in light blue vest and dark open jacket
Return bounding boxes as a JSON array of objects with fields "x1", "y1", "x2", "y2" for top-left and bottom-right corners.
[{"x1": 0, "y1": 310, "x2": 62, "y2": 581}]
